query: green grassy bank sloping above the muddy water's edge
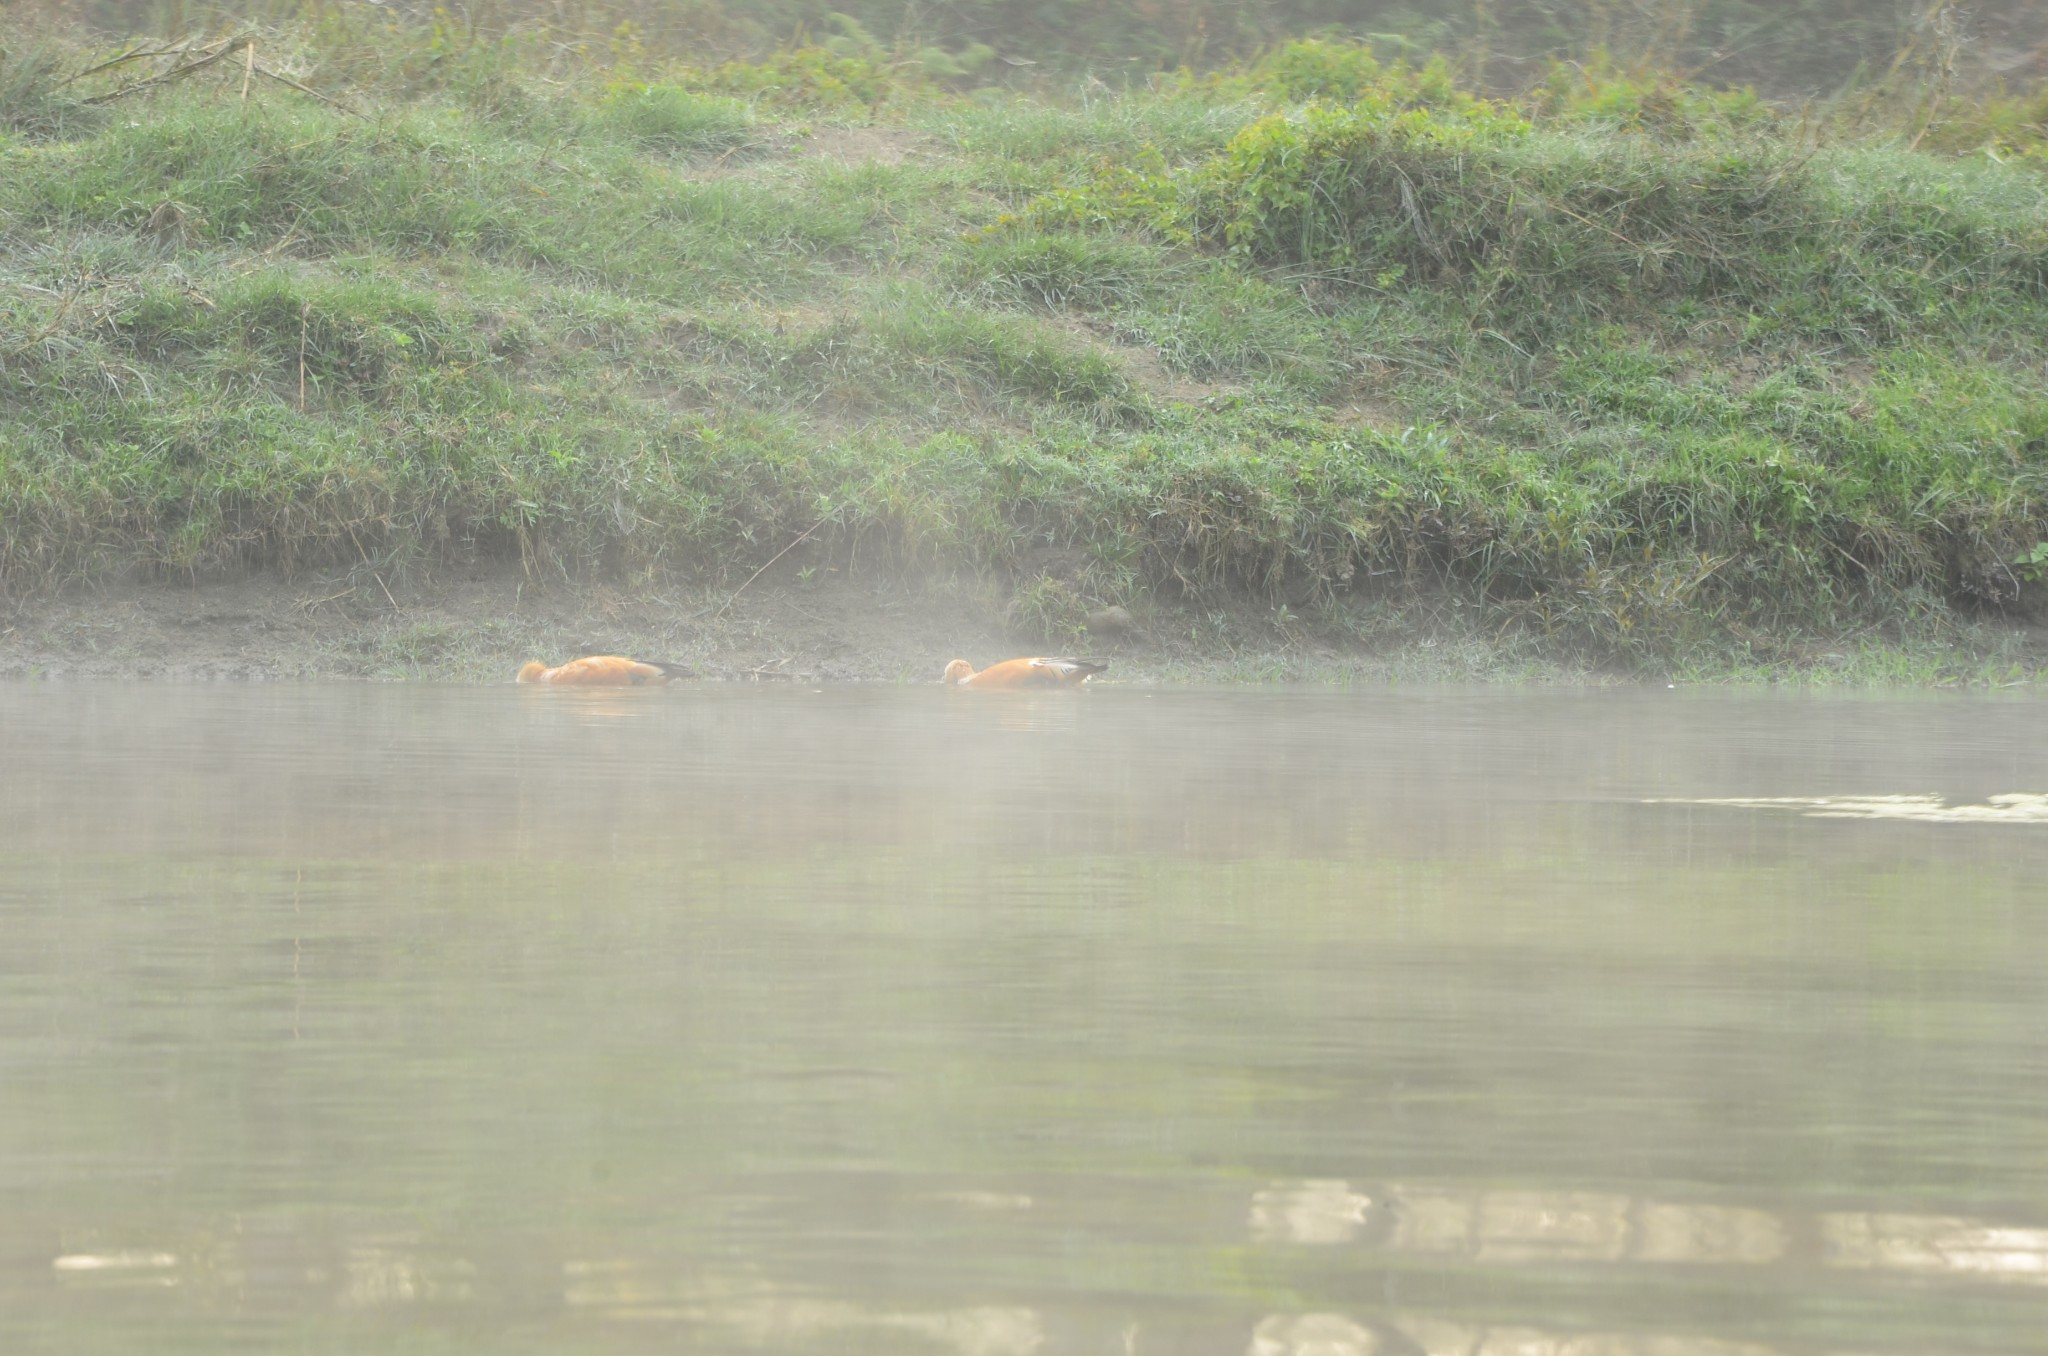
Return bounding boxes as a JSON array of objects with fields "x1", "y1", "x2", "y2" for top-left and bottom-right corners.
[{"x1": 0, "y1": 29, "x2": 2048, "y2": 672}]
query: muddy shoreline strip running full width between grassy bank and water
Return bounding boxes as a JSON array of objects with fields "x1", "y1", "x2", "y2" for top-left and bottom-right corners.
[{"x1": 0, "y1": 567, "x2": 2048, "y2": 686}]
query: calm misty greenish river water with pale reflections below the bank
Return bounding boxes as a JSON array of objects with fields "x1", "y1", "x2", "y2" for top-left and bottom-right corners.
[{"x1": 0, "y1": 684, "x2": 2048, "y2": 1356}]
